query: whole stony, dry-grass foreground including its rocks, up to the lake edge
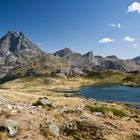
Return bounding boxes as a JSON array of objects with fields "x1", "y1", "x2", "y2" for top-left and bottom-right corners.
[{"x1": 0, "y1": 78, "x2": 140, "y2": 140}]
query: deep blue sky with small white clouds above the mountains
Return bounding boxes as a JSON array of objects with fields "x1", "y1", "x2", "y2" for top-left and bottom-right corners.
[{"x1": 0, "y1": 0, "x2": 140, "y2": 59}]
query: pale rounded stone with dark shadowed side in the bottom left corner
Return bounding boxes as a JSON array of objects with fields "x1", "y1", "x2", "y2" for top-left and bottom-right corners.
[{"x1": 0, "y1": 120, "x2": 18, "y2": 137}]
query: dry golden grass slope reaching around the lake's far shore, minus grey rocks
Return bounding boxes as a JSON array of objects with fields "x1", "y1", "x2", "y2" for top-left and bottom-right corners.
[{"x1": 0, "y1": 74, "x2": 140, "y2": 140}]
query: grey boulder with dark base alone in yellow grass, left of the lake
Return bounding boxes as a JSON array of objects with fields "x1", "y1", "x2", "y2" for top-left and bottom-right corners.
[{"x1": 33, "y1": 97, "x2": 52, "y2": 107}]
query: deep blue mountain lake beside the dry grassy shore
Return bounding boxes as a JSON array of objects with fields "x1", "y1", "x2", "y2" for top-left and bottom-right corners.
[{"x1": 80, "y1": 85, "x2": 140, "y2": 107}]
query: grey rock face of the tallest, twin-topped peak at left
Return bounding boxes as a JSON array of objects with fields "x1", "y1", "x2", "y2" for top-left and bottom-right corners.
[{"x1": 0, "y1": 31, "x2": 43, "y2": 78}]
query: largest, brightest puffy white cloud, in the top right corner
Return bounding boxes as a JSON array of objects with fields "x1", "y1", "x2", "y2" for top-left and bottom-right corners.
[{"x1": 127, "y1": 2, "x2": 140, "y2": 13}]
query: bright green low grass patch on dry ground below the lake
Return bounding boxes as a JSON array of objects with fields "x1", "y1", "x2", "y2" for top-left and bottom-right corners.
[{"x1": 85, "y1": 106, "x2": 127, "y2": 117}]
